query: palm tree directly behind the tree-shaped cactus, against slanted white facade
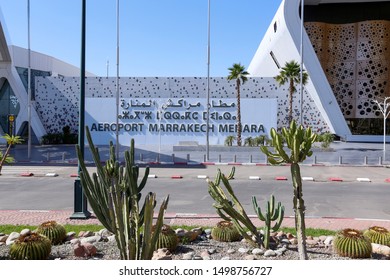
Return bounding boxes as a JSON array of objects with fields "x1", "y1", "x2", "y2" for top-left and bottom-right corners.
[{"x1": 275, "y1": 60, "x2": 309, "y2": 123}]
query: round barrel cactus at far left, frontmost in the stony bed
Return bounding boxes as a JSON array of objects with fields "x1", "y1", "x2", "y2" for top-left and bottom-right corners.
[{"x1": 9, "y1": 232, "x2": 51, "y2": 260}]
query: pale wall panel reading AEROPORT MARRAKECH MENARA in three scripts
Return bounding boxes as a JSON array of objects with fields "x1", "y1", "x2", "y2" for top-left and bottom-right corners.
[{"x1": 85, "y1": 98, "x2": 277, "y2": 146}]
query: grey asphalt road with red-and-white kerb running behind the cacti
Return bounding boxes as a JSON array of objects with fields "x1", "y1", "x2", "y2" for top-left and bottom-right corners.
[{"x1": 0, "y1": 166, "x2": 390, "y2": 220}]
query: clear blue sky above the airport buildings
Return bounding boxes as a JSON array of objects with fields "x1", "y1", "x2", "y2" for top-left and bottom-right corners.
[{"x1": 0, "y1": 0, "x2": 282, "y2": 77}]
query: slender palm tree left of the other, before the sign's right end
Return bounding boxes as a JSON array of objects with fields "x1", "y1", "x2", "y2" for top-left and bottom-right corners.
[{"x1": 227, "y1": 63, "x2": 249, "y2": 146}]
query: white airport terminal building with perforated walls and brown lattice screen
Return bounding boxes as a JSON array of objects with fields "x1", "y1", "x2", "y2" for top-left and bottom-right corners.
[{"x1": 0, "y1": 0, "x2": 390, "y2": 145}]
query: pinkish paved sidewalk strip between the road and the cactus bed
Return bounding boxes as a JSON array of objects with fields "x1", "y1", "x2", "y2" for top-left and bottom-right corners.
[{"x1": 0, "y1": 210, "x2": 390, "y2": 230}]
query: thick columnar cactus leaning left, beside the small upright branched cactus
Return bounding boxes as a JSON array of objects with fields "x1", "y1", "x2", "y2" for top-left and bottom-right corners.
[{"x1": 208, "y1": 167, "x2": 263, "y2": 247}]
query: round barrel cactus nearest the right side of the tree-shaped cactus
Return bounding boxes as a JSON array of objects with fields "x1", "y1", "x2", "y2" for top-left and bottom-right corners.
[{"x1": 333, "y1": 228, "x2": 372, "y2": 259}]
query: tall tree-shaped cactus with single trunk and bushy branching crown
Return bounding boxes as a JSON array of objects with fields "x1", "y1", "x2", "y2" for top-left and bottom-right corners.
[{"x1": 260, "y1": 120, "x2": 317, "y2": 260}]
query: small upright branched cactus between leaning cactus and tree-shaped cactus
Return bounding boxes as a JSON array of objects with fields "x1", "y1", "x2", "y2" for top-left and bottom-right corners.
[{"x1": 252, "y1": 195, "x2": 284, "y2": 249}]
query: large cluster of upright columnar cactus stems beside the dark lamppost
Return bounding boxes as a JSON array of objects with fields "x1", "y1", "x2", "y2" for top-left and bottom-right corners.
[{"x1": 76, "y1": 127, "x2": 169, "y2": 260}]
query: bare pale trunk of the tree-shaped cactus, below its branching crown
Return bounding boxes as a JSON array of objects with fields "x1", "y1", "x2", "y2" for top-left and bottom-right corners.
[{"x1": 291, "y1": 163, "x2": 308, "y2": 260}]
